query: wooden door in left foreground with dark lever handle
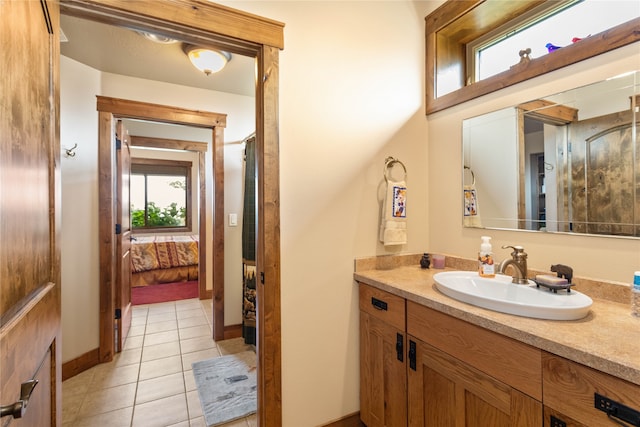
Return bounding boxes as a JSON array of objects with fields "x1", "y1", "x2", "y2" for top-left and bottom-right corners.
[{"x1": 0, "y1": 0, "x2": 62, "y2": 426}]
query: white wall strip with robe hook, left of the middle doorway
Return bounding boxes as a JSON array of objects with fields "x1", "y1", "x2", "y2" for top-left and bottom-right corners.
[{"x1": 60, "y1": 57, "x2": 100, "y2": 362}]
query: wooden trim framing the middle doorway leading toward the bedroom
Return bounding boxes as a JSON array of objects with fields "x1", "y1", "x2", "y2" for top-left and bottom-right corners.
[{"x1": 96, "y1": 96, "x2": 226, "y2": 354}]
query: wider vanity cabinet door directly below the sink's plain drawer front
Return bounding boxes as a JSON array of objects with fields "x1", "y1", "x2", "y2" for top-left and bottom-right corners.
[{"x1": 408, "y1": 336, "x2": 542, "y2": 427}]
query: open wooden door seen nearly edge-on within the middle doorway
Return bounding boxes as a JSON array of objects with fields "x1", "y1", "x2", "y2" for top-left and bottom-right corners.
[{"x1": 114, "y1": 120, "x2": 133, "y2": 352}]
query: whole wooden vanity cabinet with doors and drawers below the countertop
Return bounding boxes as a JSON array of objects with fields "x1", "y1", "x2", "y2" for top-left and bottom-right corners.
[{"x1": 360, "y1": 283, "x2": 640, "y2": 427}]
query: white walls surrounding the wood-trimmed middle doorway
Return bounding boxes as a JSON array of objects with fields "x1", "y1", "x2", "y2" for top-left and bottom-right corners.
[{"x1": 60, "y1": 57, "x2": 255, "y2": 363}]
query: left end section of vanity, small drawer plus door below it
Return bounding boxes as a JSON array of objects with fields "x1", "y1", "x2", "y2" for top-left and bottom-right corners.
[{"x1": 360, "y1": 284, "x2": 407, "y2": 427}]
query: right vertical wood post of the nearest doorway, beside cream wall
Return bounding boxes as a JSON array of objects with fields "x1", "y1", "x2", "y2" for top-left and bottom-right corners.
[{"x1": 256, "y1": 46, "x2": 282, "y2": 427}]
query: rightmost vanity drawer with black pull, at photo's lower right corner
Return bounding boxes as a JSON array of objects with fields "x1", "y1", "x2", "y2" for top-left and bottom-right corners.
[{"x1": 542, "y1": 352, "x2": 640, "y2": 426}]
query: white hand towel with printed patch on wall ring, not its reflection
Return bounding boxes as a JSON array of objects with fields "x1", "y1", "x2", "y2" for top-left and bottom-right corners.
[{"x1": 380, "y1": 181, "x2": 407, "y2": 246}]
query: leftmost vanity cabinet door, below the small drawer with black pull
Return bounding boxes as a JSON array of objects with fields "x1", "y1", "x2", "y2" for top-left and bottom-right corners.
[{"x1": 360, "y1": 311, "x2": 407, "y2": 427}]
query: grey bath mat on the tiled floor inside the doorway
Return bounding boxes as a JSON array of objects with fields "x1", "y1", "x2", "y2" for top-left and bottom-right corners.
[{"x1": 192, "y1": 351, "x2": 258, "y2": 427}]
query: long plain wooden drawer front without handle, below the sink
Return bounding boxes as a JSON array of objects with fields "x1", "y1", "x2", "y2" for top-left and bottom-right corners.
[{"x1": 407, "y1": 301, "x2": 542, "y2": 401}]
